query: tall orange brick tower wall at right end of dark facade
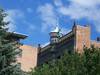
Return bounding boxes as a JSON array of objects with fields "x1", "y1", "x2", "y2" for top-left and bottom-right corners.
[{"x1": 74, "y1": 25, "x2": 90, "y2": 53}]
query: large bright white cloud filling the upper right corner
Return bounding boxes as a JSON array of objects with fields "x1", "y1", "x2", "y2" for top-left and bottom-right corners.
[{"x1": 57, "y1": 0, "x2": 100, "y2": 32}]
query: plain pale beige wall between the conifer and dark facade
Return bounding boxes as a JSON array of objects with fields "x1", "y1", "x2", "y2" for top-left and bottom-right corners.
[{"x1": 18, "y1": 45, "x2": 37, "y2": 72}]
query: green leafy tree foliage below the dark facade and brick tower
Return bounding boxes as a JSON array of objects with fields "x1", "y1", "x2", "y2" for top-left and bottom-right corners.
[{"x1": 30, "y1": 46, "x2": 100, "y2": 75}]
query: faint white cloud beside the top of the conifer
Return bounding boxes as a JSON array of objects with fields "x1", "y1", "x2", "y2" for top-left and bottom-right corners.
[{"x1": 4, "y1": 9, "x2": 24, "y2": 31}]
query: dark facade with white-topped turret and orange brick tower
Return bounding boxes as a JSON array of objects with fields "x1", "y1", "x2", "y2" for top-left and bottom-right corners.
[{"x1": 37, "y1": 24, "x2": 100, "y2": 66}]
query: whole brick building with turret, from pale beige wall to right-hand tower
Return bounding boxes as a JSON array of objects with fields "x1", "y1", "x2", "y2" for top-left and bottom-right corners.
[{"x1": 18, "y1": 25, "x2": 100, "y2": 72}]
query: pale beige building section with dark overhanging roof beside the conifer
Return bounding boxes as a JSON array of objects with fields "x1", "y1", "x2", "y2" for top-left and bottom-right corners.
[{"x1": 7, "y1": 32, "x2": 37, "y2": 72}]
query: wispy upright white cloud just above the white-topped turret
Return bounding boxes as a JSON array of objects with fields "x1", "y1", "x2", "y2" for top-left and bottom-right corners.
[{"x1": 38, "y1": 3, "x2": 58, "y2": 32}]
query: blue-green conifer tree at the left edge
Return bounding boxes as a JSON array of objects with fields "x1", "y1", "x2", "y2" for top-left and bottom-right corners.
[{"x1": 0, "y1": 9, "x2": 22, "y2": 75}]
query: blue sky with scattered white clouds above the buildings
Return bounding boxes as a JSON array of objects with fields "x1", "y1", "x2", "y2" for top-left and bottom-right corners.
[{"x1": 0, "y1": 0, "x2": 100, "y2": 46}]
